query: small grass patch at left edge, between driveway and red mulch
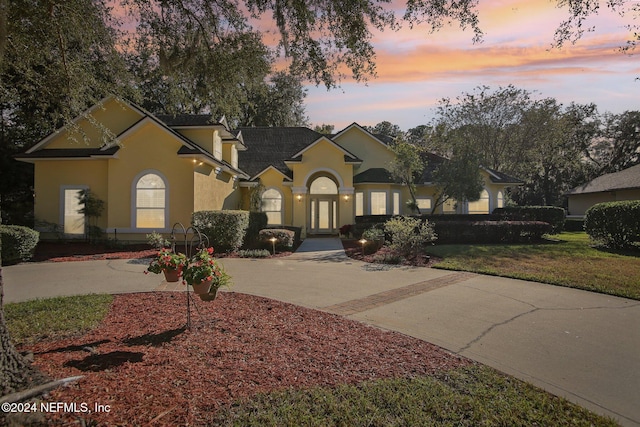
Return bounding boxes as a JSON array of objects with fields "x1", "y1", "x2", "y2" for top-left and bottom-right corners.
[{"x1": 4, "y1": 294, "x2": 113, "y2": 344}]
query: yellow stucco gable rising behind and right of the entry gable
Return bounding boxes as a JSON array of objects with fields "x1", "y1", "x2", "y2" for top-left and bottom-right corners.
[{"x1": 335, "y1": 127, "x2": 393, "y2": 174}]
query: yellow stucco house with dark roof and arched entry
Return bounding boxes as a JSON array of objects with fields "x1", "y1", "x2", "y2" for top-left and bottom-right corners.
[{"x1": 17, "y1": 98, "x2": 521, "y2": 240}]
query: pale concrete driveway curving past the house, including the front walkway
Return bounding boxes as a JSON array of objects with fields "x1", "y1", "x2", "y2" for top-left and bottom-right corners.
[{"x1": 4, "y1": 238, "x2": 640, "y2": 426}]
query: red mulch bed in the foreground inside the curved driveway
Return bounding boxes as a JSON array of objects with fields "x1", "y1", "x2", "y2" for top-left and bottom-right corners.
[{"x1": 23, "y1": 292, "x2": 471, "y2": 426}]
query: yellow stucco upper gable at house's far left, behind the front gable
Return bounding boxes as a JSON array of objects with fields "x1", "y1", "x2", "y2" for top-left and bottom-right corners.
[{"x1": 44, "y1": 98, "x2": 142, "y2": 148}]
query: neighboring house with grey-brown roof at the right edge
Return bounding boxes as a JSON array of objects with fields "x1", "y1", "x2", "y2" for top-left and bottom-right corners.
[{"x1": 565, "y1": 165, "x2": 640, "y2": 217}]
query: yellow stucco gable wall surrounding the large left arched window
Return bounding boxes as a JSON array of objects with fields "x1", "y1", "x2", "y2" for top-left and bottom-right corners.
[{"x1": 104, "y1": 122, "x2": 194, "y2": 231}]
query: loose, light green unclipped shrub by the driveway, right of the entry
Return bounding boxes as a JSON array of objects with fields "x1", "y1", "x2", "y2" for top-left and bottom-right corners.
[{"x1": 384, "y1": 216, "x2": 437, "y2": 257}]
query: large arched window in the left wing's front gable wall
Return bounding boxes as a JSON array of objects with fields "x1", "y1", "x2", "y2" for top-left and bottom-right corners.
[{"x1": 134, "y1": 172, "x2": 167, "y2": 228}]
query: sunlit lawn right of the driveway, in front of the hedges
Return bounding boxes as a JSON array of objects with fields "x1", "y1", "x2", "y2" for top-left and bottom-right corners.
[{"x1": 429, "y1": 232, "x2": 640, "y2": 299}]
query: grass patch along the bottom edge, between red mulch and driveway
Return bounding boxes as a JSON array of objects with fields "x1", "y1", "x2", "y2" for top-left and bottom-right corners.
[{"x1": 211, "y1": 366, "x2": 617, "y2": 427}]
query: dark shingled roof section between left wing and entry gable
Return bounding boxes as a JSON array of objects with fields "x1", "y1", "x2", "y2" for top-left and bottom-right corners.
[{"x1": 238, "y1": 127, "x2": 323, "y2": 181}]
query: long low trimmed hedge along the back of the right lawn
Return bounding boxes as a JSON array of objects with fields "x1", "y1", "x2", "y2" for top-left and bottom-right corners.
[{"x1": 434, "y1": 221, "x2": 551, "y2": 244}]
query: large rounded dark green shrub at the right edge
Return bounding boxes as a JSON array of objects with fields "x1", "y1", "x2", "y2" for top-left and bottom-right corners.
[{"x1": 584, "y1": 200, "x2": 640, "y2": 248}]
